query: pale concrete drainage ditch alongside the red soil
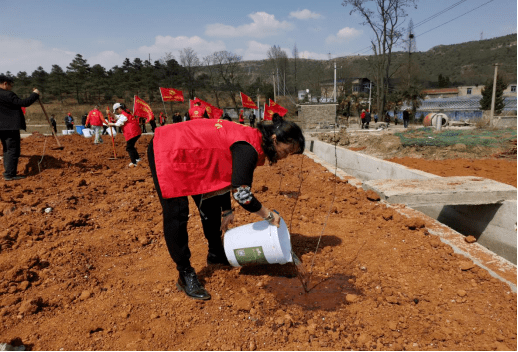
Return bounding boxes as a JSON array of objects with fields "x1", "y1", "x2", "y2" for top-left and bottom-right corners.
[{"x1": 305, "y1": 136, "x2": 517, "y2": 292}]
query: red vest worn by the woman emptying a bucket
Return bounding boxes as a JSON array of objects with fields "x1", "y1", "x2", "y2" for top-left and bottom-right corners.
[{"x1": 153, "y1": 119, "x2": 265, "y2": 198}]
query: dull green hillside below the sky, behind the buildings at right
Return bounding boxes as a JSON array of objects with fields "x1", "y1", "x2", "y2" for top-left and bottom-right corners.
[{"x1": 242, "y1": 34, "x2": 517, "y2": 89}]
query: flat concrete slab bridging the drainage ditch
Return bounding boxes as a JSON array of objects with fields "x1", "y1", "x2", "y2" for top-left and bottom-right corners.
[{"x1": 363, "y1": 176, "x2": 516, "y2": 208}]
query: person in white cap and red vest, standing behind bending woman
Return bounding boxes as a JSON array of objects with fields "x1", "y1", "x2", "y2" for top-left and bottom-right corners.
[{"x1": 108, "y1": 103, "x2": 142, "y2": 167}]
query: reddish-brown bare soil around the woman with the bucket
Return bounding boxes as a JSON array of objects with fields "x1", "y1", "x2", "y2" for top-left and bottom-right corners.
[{"x1": 0, "y1": 131, "x2": 517, "y2": 351}]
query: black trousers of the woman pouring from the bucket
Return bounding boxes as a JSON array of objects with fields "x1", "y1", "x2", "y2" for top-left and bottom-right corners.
[{"x1": 147, "y1": 140, "x2": 226, "y2": 271}]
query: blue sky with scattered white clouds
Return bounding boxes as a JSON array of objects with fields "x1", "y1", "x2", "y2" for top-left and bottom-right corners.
[{"x1": 0, "y1": 0, "x2": 517, "y2": 74}]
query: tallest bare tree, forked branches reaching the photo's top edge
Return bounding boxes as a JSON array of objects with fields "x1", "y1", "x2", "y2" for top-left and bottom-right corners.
[{"x1": 342, "y1": 0, "x2": 417, "y2": 115}]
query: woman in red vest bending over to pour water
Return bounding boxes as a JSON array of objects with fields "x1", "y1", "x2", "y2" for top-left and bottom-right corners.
[{"x1": 148, "y1": 114, "x2": 305, "y2": 300}]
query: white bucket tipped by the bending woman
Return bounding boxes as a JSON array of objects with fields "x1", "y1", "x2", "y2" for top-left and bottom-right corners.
[{"x1": 223, "y1": 218, "x2": 293, "y2": 266}]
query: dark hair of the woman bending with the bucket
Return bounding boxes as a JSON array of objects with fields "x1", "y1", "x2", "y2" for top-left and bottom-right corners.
[{"x1": 257, "y1": 114, "x2": 306, "y2": 164}]
